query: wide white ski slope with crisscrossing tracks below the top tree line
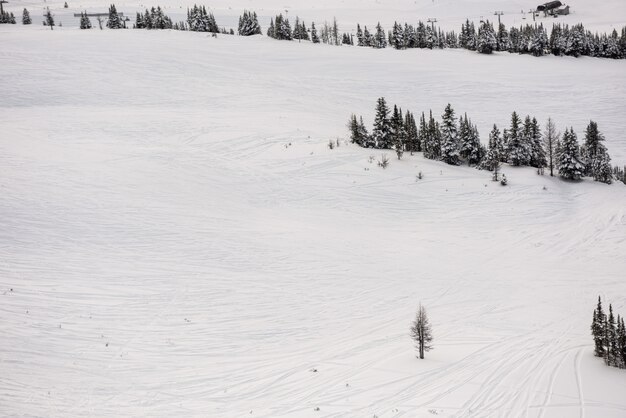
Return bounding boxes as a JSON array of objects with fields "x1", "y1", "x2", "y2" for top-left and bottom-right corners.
[{"x1": 0, "y1": 22, "x2": 626, "y2": 418}]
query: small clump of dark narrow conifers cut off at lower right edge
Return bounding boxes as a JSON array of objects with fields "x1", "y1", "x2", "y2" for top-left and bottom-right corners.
[{"x1": 591, "y1": 296, "x2": 626, "y2": 369}]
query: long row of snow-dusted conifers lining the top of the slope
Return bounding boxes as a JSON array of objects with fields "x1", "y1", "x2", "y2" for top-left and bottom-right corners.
[{"x1": 14, "y1": 5, "x2": 626, "y2": 59}]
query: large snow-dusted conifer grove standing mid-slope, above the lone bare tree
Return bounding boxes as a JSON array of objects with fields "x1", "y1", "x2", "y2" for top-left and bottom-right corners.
[{"x1": 348, "y1": 97, "x2": 615, "y2": 184}]
